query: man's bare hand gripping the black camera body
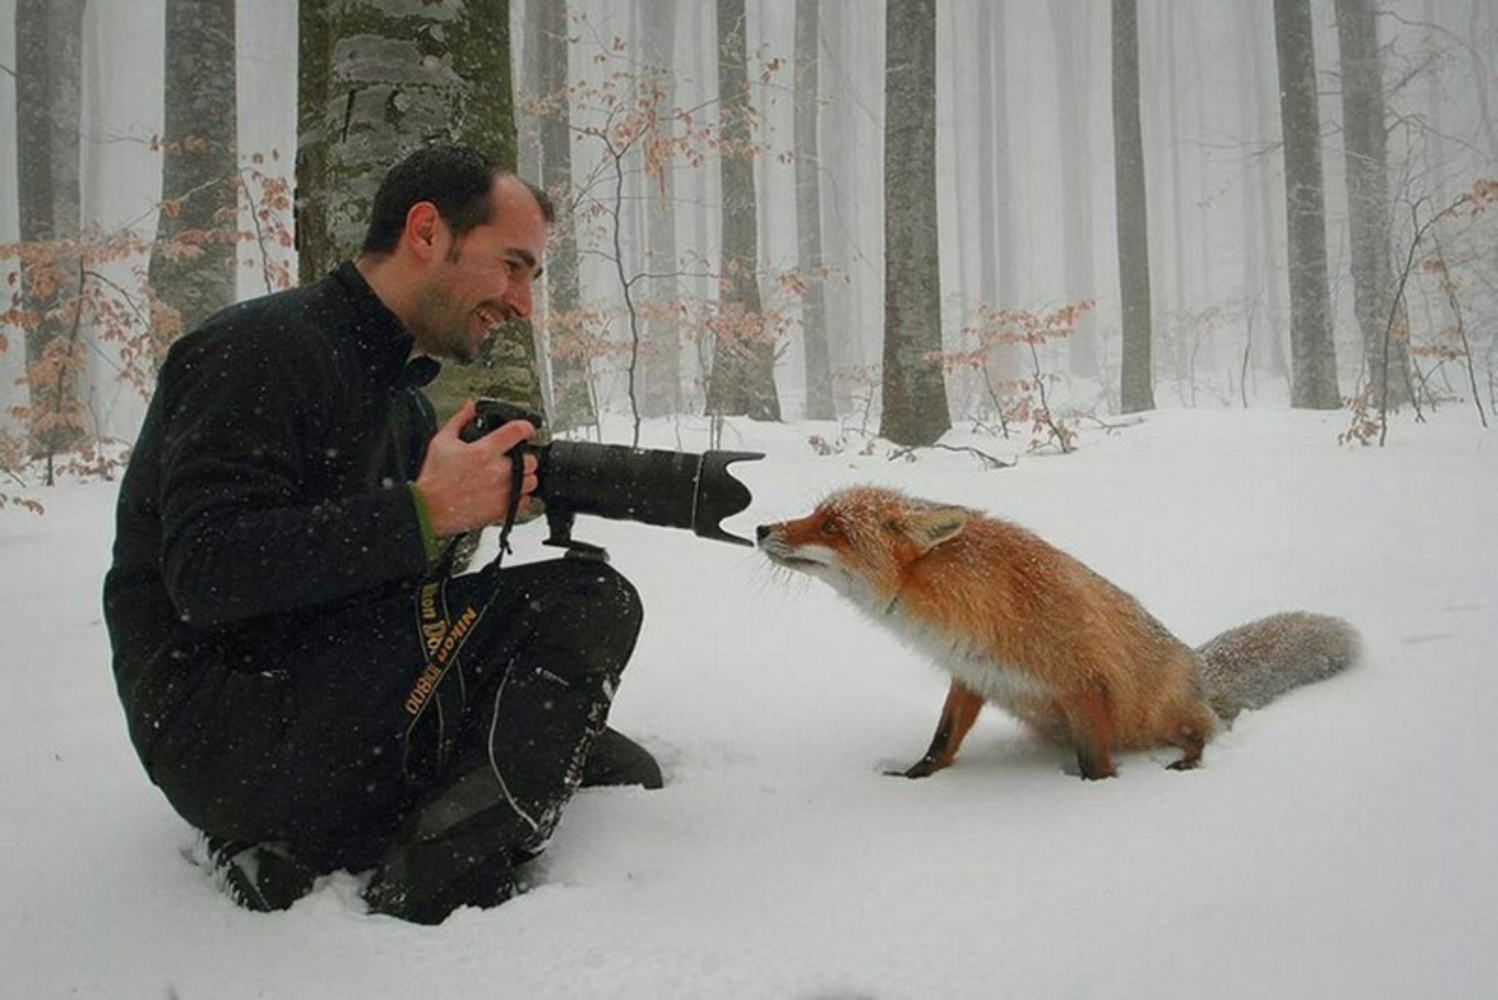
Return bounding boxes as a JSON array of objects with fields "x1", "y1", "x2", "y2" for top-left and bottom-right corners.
[{"x1": 416, "y1": 400, "x2": 536, "y2": 537}]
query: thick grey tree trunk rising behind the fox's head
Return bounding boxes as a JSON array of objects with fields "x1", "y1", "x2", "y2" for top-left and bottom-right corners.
[{"x1": 879, "y1": 0, "x2": 951, "y2": 445}]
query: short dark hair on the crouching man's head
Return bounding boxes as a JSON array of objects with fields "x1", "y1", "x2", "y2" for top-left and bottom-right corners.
[{"x1": 363, "y1": 145, "x2": 556, "y2": 253}]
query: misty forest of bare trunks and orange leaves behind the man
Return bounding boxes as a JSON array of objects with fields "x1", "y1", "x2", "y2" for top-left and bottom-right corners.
[{"x1": 0, "y1": 0, "x2": 1498, "y2": 507}]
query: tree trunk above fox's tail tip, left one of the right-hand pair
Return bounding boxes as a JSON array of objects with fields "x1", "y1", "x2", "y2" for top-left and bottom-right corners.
[{"x1": 1275, "y1": 0, "x2": 1342, "y2": 410}]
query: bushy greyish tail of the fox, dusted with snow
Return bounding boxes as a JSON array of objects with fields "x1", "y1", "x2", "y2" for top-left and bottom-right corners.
[{"x1": 1197, "y1": 611, "x2": 1362, "y2": 722}]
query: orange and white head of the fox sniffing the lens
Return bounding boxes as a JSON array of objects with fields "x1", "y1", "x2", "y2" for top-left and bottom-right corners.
[{"x1": 755, "y1": 487, "x2": 977, "y2": 603}]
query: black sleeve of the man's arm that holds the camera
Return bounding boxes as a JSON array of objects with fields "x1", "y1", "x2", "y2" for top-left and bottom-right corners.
[{"x1": 157, "y1": 318, "x2": 427, "y2": 627}]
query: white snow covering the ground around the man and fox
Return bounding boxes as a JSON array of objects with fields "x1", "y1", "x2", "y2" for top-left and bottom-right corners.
[{"x1": 0, "y1": 407, "x2": 1498, "y2": 1000}]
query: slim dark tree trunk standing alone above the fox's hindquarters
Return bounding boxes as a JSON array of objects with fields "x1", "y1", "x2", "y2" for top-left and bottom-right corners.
[{"x1": 1113, "y1": 0, "x2": 1155, "y2": 413}]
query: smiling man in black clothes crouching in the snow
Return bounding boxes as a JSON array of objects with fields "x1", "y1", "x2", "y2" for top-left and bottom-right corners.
[{"x1": 103, "y1": 147, "x2": 661, "y2": 922}]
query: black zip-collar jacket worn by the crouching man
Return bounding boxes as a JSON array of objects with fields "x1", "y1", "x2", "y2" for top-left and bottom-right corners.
[{"x1": 103, "y1": 263, "x2": 436, "y2": 771}]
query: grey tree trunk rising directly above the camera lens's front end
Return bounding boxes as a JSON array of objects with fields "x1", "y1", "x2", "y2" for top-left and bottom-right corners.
[{"x1": 707, "y1": 0, "x2": 780, "y2": 421}]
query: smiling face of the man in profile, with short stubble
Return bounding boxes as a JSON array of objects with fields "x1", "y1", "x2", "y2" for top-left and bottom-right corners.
[{"x1": 409, "y1": 177, "x2": 547, "y2": 361}]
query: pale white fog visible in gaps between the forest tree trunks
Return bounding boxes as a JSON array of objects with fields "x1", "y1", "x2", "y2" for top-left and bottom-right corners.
[{"x1": 0, "y1": 0, "x2": 1498, "y2": 439}]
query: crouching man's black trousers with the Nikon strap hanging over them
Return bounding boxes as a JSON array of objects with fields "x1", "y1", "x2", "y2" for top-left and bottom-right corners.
[{"x1": 153, "y1": 560, "x2": 643, "y2": 870}]
